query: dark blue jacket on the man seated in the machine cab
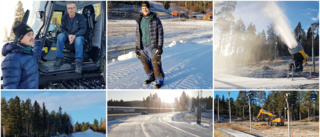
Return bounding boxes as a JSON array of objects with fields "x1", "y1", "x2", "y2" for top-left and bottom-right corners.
[{"x1": 60, "y1": 13, "x2": 87, "y2": 37}]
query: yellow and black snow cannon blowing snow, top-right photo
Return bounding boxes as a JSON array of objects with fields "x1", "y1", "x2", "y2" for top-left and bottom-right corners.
[{"x1": 288, "y1": 43, "x2": 309, "y2": 72}]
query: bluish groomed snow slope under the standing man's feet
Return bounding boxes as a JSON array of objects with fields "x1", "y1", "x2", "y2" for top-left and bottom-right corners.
[{"x1": 107, "y1": 35, "x2": 213, "y2": 89}]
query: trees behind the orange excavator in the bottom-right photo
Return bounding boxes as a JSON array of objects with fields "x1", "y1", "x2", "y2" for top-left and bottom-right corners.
[{"x1": 214, "y1": 91, "x2": 319, "y2": 120}]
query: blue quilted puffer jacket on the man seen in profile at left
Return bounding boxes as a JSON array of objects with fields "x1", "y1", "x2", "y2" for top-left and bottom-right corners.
[{"x1": 1, "y1": 41, "x2": 42, "y2": 89}]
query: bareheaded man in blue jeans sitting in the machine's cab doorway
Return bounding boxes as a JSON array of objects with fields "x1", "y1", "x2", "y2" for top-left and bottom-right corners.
[{"x1": 54, "y1": 2, "x2": 87, "y2": 73}]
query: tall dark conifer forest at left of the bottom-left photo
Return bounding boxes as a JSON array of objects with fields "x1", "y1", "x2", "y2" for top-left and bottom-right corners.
[{"x1": 1, "y1": 96, "x2": 73, "y2": 137}]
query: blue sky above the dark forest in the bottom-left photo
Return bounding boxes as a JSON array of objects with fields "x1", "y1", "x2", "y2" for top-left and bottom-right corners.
[{"x1": 1, "y1": 91, "x2": 106, "y2": 124}]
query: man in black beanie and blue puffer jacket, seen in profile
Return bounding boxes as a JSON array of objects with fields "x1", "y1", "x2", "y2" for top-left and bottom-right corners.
[{"x1": 1, "y1": 24, "x2": 42, "y2": 89}]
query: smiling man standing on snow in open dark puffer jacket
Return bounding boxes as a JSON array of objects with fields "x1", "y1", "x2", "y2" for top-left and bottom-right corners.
[{"x1": 136, "y1": 2, "x2": 164, "y2": 89}]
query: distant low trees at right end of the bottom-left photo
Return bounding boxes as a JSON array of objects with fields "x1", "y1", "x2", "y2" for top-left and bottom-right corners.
[{"x1": 74, "y1": 119, "x2": 106, "y2": 133}]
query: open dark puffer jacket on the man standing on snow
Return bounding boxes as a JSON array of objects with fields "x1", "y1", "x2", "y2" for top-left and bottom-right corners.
[{"x1": 136, "y1": 12, "x2": 163, "y2": 54}]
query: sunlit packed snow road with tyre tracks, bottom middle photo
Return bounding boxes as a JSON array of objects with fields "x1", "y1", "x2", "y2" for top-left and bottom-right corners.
[{"x1": 108, "y1": 113, "x2": 212, "y2": 137}]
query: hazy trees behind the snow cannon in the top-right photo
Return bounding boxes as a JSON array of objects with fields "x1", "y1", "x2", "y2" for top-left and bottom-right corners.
[{"x1": 214, "y1": 1, "x2": 319, "y2": 63}]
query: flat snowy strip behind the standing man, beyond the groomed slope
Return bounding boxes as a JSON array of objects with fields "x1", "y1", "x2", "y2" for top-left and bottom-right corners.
[{"x1": 108, "y1": 19, "x2": 212, "y2": 51}]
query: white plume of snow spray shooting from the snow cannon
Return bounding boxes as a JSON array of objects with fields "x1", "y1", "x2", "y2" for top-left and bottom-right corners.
[{"x1": 263, "y1": 2, "x2": 298, "y2": 49}]
